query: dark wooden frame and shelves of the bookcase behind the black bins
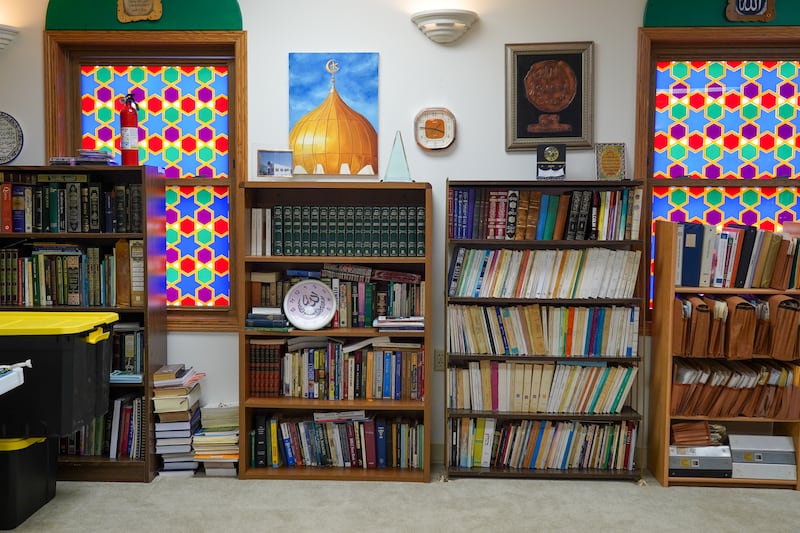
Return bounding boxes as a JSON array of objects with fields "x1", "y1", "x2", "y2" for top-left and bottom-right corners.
[{"x1": 0, "y1": 166, "x2": 167, "y2": 482}]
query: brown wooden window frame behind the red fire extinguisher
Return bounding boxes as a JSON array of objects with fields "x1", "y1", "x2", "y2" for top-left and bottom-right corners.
[{"x1": 44, "y1": 31, "x2": 248, "y2": 331}]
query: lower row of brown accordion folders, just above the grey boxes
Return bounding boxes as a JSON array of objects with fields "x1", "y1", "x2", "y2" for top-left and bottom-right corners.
[{"x1": 670, "y1": 358, "x2": 800, "y2": 420}]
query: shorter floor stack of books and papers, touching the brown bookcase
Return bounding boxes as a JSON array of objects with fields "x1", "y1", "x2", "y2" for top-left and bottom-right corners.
[{"x1": 192, "y1": 403, "x2": 239, "y2": 477}]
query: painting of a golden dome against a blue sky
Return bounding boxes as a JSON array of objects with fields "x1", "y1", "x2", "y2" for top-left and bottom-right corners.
[{"x1": 289, "y1": 52, "x2": 378, "y2": 175}]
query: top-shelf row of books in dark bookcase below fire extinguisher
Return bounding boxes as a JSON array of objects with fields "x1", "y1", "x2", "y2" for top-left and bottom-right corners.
[{"x1": 0, "y1": 179, "x2": 142, "y2": 233}]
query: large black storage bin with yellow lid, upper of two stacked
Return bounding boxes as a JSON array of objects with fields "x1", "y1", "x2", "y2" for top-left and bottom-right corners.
[{"x1": 0, "y1": 311, "x2": 119, "y2": 438}]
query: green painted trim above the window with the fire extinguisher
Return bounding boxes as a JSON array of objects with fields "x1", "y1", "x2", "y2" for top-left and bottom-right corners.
[{"x1": 45, "y1": 0, "x2": 242, "y2": 31}]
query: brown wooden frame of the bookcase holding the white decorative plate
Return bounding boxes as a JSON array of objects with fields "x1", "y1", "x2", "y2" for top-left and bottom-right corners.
[{"x1": 237, "y1": 180, "x2": 433, "y2": 482}]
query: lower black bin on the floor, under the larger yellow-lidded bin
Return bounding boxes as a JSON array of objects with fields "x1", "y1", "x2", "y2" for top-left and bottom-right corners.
[{"x1": 0, "y1": 437, "x2": 58, "y2": 529}]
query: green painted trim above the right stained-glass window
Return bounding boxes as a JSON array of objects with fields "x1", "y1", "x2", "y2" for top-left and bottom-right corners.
[{"x1": 642, "y1": 0, "x2": 800, "y2": 28}]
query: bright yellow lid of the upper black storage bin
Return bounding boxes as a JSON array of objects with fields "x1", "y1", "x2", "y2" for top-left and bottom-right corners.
[{"x1": 0, "y1": 311, "x2": 119, "y2": 336}]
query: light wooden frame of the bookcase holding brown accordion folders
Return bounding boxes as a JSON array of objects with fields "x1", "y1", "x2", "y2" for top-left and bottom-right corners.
[{"x1": 647, "y1": 218, "x2": 800, "y2": 490}]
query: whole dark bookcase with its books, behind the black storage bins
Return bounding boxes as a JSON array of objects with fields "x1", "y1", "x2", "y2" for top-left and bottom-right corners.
[{"x1": 0, "y1": 166, "x2": 167, "y2": 482}]
